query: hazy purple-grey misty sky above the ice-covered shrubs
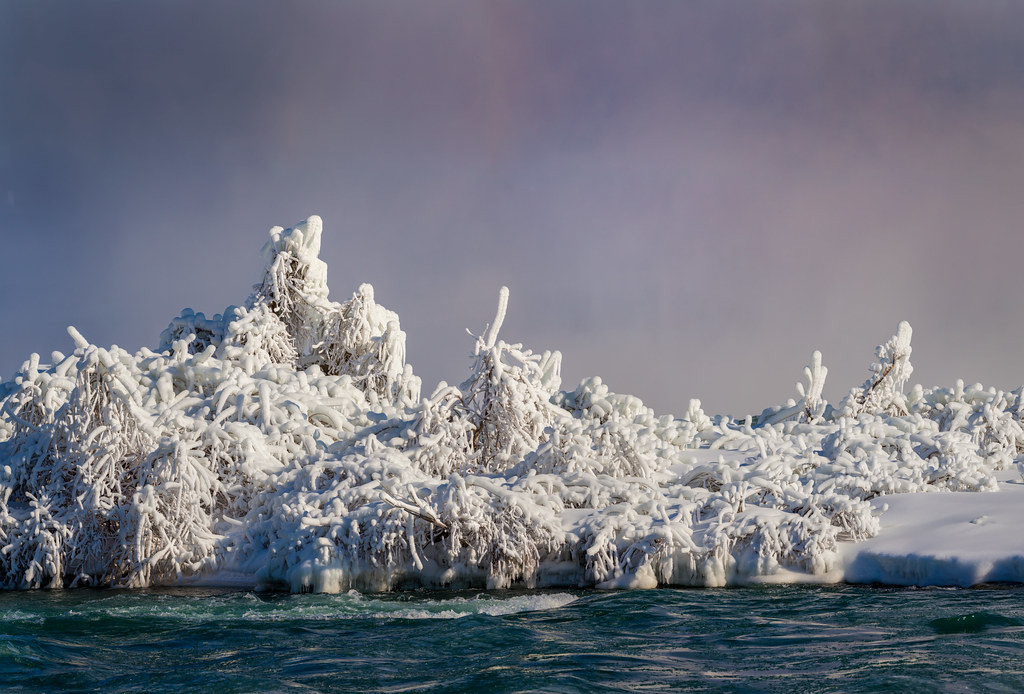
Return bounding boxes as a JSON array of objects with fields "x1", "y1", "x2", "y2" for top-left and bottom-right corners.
[{"x1": 0, "y1": 0, "x2": 1024, "y2": 416}]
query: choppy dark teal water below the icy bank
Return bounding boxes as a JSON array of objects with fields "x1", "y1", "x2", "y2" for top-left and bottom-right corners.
[{"x1": 0, "y1": 585, "x2": 1024, "y2": 694}]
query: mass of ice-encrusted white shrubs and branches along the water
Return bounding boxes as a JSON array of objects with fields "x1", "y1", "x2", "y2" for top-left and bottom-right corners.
[{"x1": 0, "y1": 217, "x2": 1024, "y2": 592}]
